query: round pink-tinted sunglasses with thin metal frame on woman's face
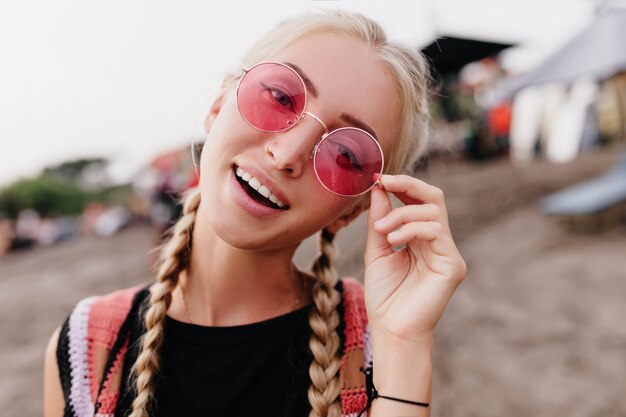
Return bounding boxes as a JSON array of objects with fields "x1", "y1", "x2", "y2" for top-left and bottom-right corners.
[{"x1": 237, "y1": 62, "x2": 384, "y2": 197}]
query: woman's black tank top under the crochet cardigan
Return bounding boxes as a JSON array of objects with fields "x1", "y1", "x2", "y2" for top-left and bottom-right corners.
[{"x1": 115, "y1": 281, "x2": 345, "y2": 417}]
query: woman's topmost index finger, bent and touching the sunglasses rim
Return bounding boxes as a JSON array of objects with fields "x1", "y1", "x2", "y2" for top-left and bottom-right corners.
[{"x1": 379, "y1": 175, "x2": 448, "y2": 219}]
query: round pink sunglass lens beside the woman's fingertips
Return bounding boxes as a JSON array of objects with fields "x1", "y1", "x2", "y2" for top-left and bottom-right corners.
[{"x1": 314, "y1": 127, "x2": 383, "y2": 196}]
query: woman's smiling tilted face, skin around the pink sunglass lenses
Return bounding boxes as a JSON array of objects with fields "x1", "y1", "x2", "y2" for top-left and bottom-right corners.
[{"x1": 199, "y1": 33, "x2": 400, "y2": 250}]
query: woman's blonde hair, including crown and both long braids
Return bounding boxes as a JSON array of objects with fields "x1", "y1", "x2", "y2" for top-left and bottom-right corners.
[{"x1": 131, "y1": 11, "x2": 429, "y2": 417}]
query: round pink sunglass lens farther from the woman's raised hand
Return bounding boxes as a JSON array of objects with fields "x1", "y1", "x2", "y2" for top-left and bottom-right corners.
[{"x1": 237, "y1": 62, "x2": 306, "y2": 132}]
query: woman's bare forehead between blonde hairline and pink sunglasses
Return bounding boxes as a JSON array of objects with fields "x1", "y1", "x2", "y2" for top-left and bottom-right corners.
[{"x1": 272, "y1": 33, "x2": 400, "y2": 150}]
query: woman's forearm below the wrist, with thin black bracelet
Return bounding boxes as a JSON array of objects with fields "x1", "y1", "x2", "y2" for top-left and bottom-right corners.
[{"x1": 368, "y1": 333, "x2": 432, "y2": 417}]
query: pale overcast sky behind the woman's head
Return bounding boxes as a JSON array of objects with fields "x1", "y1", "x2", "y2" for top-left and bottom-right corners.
[{"x1": 0, "y1": 0, "x2": 593, "y2": 186}]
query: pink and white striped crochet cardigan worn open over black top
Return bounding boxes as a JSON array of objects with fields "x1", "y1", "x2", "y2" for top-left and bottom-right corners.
[{"x1": 57, "y1": 278, "x2": 372, "y2": 417}]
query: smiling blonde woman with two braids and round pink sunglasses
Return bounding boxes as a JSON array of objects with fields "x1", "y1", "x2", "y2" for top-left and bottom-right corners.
[{"x1": 44, "y1": 12, "x2": 466, "y2": 417}]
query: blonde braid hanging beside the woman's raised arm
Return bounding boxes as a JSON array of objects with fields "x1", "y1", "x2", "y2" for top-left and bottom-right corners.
[{"x1": 308, "y1": 229, "x2": 341, "y2": 417}]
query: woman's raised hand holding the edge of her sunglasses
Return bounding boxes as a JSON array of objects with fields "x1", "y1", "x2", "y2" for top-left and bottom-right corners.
[{"x1": 365, "y1": 175, "x2": 467, "y2": 343}]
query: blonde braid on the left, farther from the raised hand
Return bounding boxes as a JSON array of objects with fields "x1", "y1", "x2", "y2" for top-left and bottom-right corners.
[{"x1": 130, "y1": 188, "x2": 200, "y2": 417}]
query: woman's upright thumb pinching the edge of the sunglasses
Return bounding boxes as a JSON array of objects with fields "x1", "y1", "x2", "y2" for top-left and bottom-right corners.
[{"x1": 365, "y1": 187, "x2": 393, "y2": 266}]
